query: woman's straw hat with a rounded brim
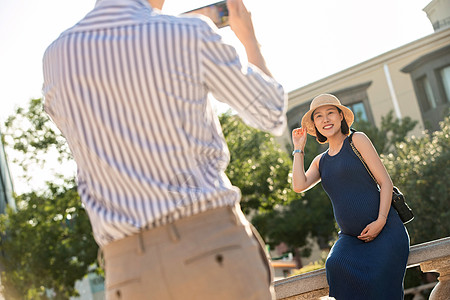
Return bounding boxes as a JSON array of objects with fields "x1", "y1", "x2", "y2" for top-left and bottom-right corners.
[{"x1": 302, "y1": 94, "x2": 355, "y2": 136}]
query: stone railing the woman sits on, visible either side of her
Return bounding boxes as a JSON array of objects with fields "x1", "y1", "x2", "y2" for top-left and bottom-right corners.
[{"x1": 275, "y1": 237, "x2": 450, "y2": 300}]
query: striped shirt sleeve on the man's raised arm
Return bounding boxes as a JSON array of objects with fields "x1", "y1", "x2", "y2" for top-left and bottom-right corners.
[{"x1": 201, "y1": 24, "x2": 287, "y2": 135}]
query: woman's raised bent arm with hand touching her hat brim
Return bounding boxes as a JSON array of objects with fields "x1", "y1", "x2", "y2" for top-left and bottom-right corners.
[{"x1": 292, "y1": 128, "x2": 322, "y2": 193}]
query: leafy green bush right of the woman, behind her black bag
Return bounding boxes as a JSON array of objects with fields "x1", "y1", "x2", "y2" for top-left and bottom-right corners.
[{"x1": 382, "y1": 117, "x2": 450, "y2": 244}]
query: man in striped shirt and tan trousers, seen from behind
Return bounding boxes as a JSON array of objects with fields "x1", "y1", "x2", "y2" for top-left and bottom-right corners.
[{"x1": 43, "y1": 0, "x2": 285, "y2": 300}]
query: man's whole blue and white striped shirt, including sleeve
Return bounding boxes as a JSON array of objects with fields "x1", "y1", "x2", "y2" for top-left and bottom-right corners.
[{"x1": 43, "y1": 0, "x2": 286, "y2": 246}]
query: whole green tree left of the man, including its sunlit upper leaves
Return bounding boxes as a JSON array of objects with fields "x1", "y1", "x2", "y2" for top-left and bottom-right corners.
[{"x1": 0, "y1": 99, "x2": 98, "y2": 299}]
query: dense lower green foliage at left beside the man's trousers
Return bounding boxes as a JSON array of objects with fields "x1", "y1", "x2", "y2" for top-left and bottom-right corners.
[{"x1": 0, "y1": 182, "x2": 97, "y2": 299}]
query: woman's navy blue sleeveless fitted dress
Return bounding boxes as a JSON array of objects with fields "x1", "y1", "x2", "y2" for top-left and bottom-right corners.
[{"x1": 319, "y1": 137, "x2": 409, "y2": 300}]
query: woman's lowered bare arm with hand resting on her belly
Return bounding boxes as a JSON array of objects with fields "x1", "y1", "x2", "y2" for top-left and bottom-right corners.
[{"x1": 353, "y1": 132, "x2": 393, "y2": 241}]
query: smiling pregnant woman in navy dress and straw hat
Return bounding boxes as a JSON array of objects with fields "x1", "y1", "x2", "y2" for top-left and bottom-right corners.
[{"x1": 292, "y1": 94, "x2": 409, "y2": 300}]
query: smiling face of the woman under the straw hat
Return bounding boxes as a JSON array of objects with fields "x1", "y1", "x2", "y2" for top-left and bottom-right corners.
[{"x1": 313, "y1": 105, "x2": 344, "y2": 137}]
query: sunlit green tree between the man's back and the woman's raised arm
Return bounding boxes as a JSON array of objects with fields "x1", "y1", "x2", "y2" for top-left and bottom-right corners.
[{"x1": 219, "y1": 112, "x2": 295, "y2": 213}]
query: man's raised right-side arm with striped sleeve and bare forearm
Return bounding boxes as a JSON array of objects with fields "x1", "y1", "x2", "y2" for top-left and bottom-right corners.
[{"x1": 200, "y1": 0, "x2": 287, "y2": 135}]
